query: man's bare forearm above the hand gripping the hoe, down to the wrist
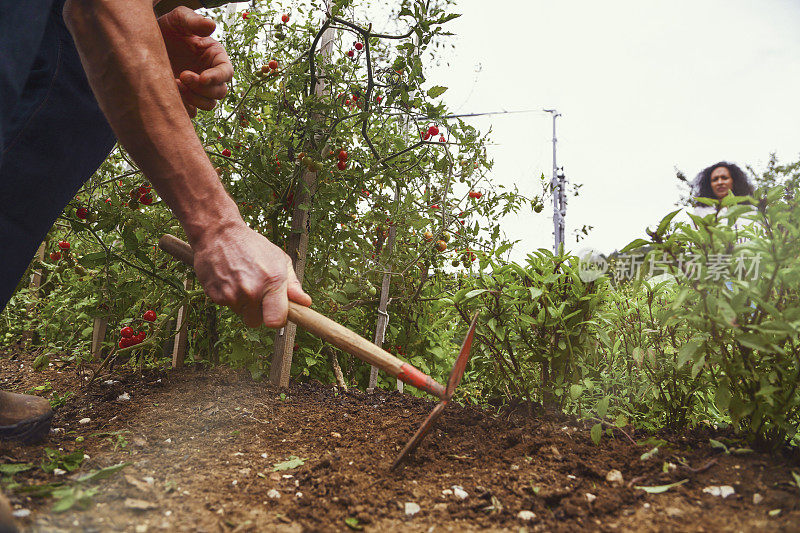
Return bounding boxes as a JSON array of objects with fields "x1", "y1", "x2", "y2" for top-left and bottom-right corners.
[{"x1": 64, "y1": 0, "x2": 241, "y2": 245}]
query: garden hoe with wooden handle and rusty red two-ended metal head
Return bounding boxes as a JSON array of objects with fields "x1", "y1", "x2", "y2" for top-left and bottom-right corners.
[{"x1": 158, "y1": 235, "x2": 478, "y2": 469}]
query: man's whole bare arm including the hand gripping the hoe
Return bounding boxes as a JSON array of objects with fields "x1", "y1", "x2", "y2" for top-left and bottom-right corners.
[{"x1": 58, "y1": 0, "x2": 311, "y2": 327}]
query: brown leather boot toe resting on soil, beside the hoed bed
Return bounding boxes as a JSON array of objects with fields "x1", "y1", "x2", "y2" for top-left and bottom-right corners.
[{"x1": 0, "y1": 391, "x2": 53, "y2": 444}]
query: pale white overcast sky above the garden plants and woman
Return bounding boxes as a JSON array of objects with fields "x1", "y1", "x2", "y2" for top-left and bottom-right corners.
[{"x1": 429, "y1": 0, "x2": 800, "y2": 259}]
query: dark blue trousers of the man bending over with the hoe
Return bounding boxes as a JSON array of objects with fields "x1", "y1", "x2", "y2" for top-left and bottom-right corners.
[{"x1": 0, "y1": 0, "x2": 116, "y2": 310}]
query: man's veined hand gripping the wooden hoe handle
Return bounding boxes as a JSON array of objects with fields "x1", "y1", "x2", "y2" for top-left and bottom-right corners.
[{"x1": 193, "y1": 224, "x2": 311, "y2": 328}]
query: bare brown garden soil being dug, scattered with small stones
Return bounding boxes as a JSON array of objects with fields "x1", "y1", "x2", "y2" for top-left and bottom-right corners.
[{"x1": 0, "y1": 353, "x2": 800, "y2": 532}]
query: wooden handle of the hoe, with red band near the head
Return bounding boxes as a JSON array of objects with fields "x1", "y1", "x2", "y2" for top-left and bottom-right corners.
[{"x1": 158, "y1": 235, "x2": 446, "y2": 399}]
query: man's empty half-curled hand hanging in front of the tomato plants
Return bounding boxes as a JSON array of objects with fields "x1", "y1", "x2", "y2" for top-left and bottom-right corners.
[{"x1": 158, "y1": 6, "x2": 233, "y2": 118}]
